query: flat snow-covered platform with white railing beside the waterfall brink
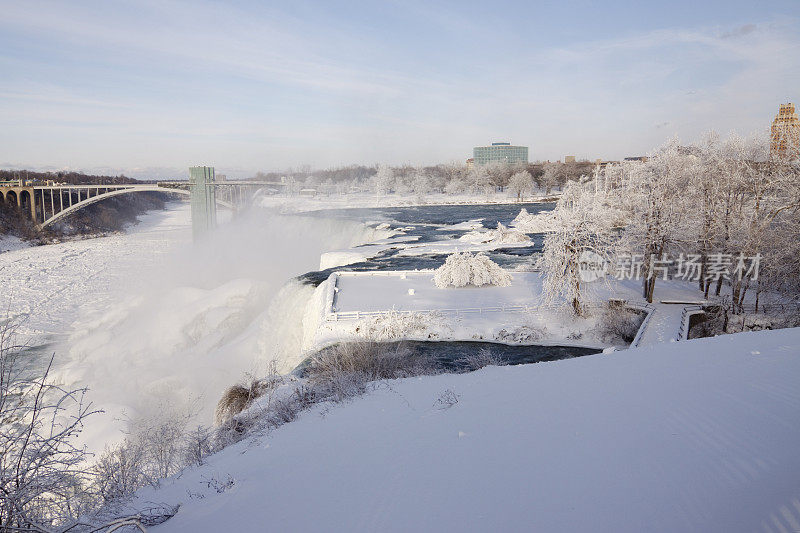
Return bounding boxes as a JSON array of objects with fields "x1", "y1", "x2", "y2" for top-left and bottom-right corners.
[{"x1": 304, "y1": 270, "x2": 720, "y2": 351}]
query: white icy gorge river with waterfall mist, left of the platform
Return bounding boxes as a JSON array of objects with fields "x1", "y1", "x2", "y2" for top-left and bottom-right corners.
[{"x1": 0, "y1": 203, "x2": 394, "y2": 451}]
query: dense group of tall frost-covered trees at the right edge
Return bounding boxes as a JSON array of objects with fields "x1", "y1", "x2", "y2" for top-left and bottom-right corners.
[{"x1": 542, "y1": 132, "x2": 800, "y2": 315}]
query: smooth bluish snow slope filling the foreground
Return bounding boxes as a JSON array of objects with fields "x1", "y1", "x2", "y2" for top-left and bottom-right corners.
[{"x1": 132, "y1": 329, "x2": 800, "y2": 533}]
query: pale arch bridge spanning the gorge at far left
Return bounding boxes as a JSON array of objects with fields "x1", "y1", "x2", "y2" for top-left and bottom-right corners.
[{"x1": 0, "y1": 178, "x2": 283, "y2": 228}]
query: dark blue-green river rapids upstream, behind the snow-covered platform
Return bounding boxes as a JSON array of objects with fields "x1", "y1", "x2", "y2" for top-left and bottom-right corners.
[{"x1": 299, "y1": 203, "x2": 555, "y2": 286}]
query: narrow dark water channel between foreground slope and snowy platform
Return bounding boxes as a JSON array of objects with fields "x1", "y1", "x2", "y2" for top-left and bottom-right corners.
[{"x1": 294, "y1": 341, "x2": 600, "y2": 376}]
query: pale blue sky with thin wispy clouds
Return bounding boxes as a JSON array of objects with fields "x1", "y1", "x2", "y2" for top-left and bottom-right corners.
[{"x1": 0, "y1": 0, "x2": 800, "y2": 178}]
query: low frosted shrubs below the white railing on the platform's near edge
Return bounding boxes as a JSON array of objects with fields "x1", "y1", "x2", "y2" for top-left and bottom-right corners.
[{"x1": 355, "y1": 310, "x2": 449, "y2": 341}]
